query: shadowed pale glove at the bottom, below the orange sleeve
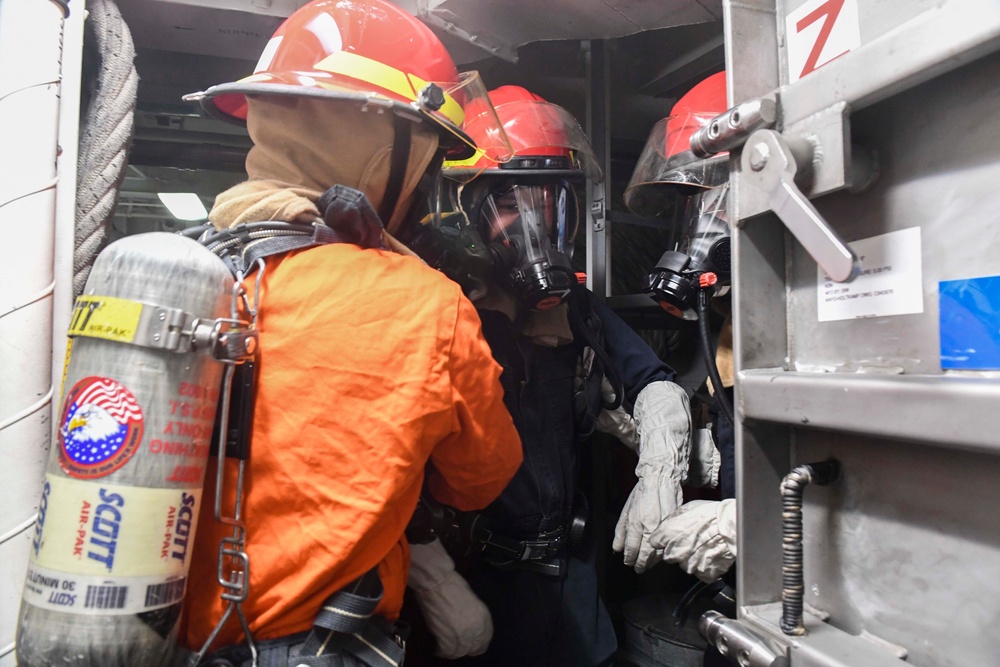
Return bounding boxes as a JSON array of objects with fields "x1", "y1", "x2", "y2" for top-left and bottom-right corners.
[{"x1": 407, "y1": 538, "x2": 493, "y2": 659}]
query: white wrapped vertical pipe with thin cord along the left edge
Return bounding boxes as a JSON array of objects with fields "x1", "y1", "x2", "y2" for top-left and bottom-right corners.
[{"x1": 0, "y1": 0, "x2": 63, "y2": 664}]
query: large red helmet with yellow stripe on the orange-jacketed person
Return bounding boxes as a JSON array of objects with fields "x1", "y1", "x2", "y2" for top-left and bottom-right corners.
[{"x1": 185, "y1": 0, "x2": 486, "y2": 156}]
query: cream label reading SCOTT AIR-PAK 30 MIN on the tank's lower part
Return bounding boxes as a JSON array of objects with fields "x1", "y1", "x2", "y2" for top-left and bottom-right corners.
[{"x1": 24, "y1": 474, "x2": 202, "y2": 614}]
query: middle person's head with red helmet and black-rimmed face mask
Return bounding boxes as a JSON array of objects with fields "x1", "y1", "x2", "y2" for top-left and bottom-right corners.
[{"x1": 435, "y1": 86, "x2": 603, "y2": 310}]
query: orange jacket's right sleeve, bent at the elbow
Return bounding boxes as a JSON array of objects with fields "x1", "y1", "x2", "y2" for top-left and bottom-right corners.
[{"x1": 427, "y1": 294, "x2": 522, "y2": 511}]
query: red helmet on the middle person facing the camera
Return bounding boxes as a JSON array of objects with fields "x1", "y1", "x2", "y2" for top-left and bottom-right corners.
[{"x1": 444, "y1": 86, "x2": 604, "y2": 182}]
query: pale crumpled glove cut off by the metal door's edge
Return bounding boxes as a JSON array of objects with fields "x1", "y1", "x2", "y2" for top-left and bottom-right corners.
[{"x1": 650, "y1": 498, "x2": 736, "y2": 583}]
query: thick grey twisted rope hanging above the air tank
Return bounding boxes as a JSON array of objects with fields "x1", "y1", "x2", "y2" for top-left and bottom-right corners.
[{"x1": 73, "y1": 0, "x2": 139, "y2": 296}]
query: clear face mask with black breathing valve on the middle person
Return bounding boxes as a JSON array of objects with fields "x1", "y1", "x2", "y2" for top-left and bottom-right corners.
[{"x1": 478, "y1": 182, "x2": 579, "y2": 310}]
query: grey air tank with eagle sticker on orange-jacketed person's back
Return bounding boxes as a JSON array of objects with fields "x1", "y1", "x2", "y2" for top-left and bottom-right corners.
[{"x1": 17, "y1": 233, "x2": 233, "y2": 667}]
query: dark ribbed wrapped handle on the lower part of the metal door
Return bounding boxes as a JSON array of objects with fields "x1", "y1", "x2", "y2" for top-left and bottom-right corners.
[{"x1": 781, "y1": 459, "x2": 840, "y2": 635}]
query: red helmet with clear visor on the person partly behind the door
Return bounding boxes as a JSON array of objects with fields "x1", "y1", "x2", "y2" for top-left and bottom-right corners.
[{"x1": 625, "y1": 71, "x2": 729, "y2": 216}]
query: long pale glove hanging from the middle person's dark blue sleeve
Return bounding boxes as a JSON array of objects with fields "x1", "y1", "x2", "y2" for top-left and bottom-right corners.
[{"x1": 611, "y1": 381, "x2": 691, "y2": 572}]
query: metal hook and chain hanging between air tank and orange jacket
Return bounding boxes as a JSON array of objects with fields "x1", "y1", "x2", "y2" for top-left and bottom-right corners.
[{"x1": 189, "y1": 259, "x2": 265, "y2": 667}]
